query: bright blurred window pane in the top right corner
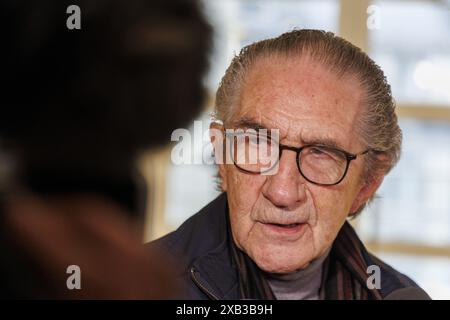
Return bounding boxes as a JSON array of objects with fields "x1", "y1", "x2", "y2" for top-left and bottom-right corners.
[{"x1": 369, "y1": 0, "x2": 450, "y2": 107}]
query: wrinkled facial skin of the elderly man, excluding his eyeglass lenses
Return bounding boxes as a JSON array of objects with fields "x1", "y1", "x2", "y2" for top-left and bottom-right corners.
[{"x1": 212, "y1": 57, "x2": 383, "y2": 273}]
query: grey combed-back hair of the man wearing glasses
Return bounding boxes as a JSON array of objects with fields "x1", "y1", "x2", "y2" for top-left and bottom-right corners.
[{"x1": 215, "y1": 29, "x2": 402, "y2": 214}]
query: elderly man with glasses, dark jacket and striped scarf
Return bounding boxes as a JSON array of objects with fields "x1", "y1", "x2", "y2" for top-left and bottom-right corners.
[{"x1": 155, "y1": 30, "x2": 427, "y2": 299}]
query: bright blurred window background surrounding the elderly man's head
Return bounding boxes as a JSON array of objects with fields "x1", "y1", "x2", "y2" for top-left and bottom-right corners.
[{"x1": 141, "y1": 0, "x2": 450, "y2": 299}]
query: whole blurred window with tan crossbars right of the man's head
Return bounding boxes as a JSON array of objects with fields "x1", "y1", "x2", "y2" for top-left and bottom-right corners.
[{"x1": 356, "y1": 0, "x2": 450, "y2": 299}]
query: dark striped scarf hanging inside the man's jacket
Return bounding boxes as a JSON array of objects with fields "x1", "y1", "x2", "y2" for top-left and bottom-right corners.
[{"x1": 228, "y1": 222, "x2": 382, "y2": 300}]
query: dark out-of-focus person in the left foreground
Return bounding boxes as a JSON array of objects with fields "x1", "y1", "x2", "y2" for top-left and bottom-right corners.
[{"x1": 0, "y1": 0, "x2": 211, "y2": 298}]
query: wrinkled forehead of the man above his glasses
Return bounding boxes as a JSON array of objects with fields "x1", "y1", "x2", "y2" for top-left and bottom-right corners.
[{"x1": 232, "y1": 57, "x2": 363, "y2": 149}]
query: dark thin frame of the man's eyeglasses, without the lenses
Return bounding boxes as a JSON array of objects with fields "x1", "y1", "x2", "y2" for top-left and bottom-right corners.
[{"x1": 224, "y1": 131, "x2": 374, "y2": 186}]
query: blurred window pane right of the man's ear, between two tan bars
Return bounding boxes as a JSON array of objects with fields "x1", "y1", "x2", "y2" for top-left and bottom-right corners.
[{"x1": 359, "y1": 119, "x2": 450, "y2": 246}]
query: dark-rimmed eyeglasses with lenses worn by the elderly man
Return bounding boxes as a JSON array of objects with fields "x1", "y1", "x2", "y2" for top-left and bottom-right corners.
[{"x1": 226, "y1": 132, "x2": 370, "y2": 186}]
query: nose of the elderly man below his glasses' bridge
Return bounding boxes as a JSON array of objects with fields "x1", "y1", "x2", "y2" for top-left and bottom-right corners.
[{"x1": 262, "y1": 150, "x2": 305, "y2": 210}]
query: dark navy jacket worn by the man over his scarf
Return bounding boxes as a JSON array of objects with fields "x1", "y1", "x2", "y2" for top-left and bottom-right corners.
[{"x1": 150, "y1": 193, "x2": 429, "y2": 299}]
